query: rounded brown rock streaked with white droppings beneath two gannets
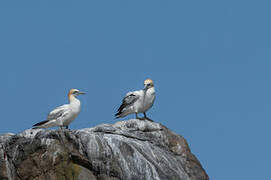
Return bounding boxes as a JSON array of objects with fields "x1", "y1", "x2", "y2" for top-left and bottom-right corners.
[{"x1": 0, "y1": 119, "x2": 209, "y2": 180}]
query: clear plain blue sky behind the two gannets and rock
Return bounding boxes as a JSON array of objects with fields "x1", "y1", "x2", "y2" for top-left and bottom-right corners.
[{"x1": 0, "y1": 0, "x2": 271, "y2": 180}]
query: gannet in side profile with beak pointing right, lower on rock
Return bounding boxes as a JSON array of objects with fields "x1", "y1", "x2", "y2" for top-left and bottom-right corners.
[{"x1": 33, "y1": 89, "x2": 85, "y2": 129}]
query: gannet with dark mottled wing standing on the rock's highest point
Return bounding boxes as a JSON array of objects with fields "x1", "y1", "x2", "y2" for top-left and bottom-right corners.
[{"x1": 115, "y1": 79, "x2": 155, "y2": 121}]
